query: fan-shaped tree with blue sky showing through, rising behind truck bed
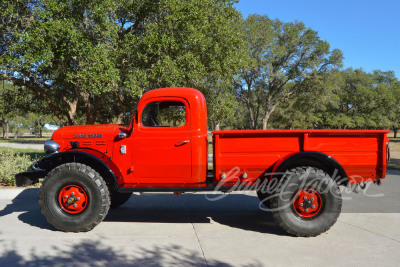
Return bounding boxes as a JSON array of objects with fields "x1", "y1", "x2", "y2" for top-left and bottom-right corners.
[{"x1": 237, "y1": 15, "x2": 342, "y2": 129}]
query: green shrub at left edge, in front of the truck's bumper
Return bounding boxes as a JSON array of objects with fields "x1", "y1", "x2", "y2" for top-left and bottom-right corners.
[{"x1": 0, "y1": 150, "x2": 32, "y2": 186}]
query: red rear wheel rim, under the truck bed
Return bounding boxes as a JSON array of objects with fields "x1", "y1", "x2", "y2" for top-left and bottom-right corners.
[{"x1": 293, "y1": 189, "x2": 322, "y2": 218}]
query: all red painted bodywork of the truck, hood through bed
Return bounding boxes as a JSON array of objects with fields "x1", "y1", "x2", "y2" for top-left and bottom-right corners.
[{"x1": 53, "y1": 88, "x2": 389, "y2": 188}]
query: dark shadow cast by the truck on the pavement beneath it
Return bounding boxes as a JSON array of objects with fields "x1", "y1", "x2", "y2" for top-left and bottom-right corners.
[{"x1": 0, "y1": 188, "x2": 286, "y2": 235}]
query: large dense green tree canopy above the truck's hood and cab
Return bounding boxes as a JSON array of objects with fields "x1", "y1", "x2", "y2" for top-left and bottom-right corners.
[{"x1": 0, "y1": 0, "x2": 242, "y2": 124}]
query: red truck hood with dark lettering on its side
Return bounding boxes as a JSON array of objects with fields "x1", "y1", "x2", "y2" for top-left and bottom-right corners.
[{"x1": 52, "y1": 124, "x2": 128, "y2": 151}]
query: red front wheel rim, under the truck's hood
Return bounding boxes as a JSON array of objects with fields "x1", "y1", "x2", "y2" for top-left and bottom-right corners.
[{"x1": 58, "y1": 185, "x2": 88, "y2": 214}]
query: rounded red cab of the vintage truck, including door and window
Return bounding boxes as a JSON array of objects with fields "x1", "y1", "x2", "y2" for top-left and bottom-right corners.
[{"x1": 130, "y1": 88, "x2": 208, "y2": 184}]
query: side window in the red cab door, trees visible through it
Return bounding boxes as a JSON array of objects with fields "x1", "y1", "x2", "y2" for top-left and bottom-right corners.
[{"x1": 142, "y1": 101, "x2": 186, "y2": 127}]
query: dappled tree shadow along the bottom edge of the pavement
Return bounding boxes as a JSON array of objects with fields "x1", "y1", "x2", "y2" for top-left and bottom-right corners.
[{"x1": 0, "y1": 240, "x2": 262, "y2": 267}]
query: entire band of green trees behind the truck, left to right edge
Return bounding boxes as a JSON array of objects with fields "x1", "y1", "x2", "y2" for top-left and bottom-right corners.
[{"x1": 0, "y1": 0, "x2": 400, "y2": 134}]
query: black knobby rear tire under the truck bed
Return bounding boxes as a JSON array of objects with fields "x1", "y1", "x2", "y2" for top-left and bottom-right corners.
[{"x1": 271, "y1": 166, "x2": 342, "y2": 237}]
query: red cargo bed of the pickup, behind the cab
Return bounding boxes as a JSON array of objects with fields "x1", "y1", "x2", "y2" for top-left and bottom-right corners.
[{"x1": 213, "y1": 130, "x2": 389, "y2": 183}]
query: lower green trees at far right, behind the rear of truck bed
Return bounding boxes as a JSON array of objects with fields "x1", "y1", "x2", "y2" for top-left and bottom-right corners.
[{"x1": 272, "y1": 68, "x2": 400, "y2": 132}]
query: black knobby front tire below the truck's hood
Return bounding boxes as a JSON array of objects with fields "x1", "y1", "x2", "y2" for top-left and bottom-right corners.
[{"x1": 39, "y1": 163, "x2": 110, "y2": 232}]
